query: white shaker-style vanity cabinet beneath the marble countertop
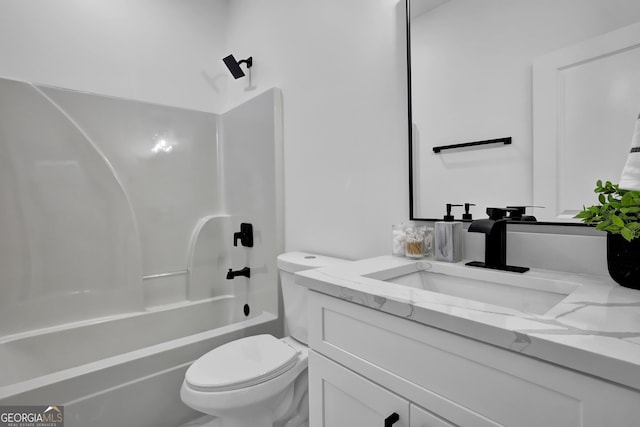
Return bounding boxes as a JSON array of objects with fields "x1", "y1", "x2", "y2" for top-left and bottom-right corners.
[{"x1": 309, "y1": 291, "x2": 640, "y2": 427}]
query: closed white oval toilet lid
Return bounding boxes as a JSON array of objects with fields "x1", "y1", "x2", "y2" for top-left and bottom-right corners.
[{"x1": 185, "y1": 335, "x2": 298, "y2": 391}]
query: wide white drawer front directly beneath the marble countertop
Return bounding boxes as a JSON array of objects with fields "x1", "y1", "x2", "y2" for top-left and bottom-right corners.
[{"x1": 309, "y1": 292, "x2": 640, "y2": 427}]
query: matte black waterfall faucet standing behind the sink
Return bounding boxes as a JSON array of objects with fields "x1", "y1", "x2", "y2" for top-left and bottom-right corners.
[{"x1": 467, "y1": 208, "x2": 529, "y2": 273}]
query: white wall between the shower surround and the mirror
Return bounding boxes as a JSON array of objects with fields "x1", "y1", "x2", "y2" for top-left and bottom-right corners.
[{"x1": 222, "y1": 0, "x2": 408, "y2": 258}]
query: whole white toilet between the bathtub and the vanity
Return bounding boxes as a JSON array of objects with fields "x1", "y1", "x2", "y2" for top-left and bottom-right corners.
[{"x1": 180, "y1": 252, "x2": 345, "y2": 427}]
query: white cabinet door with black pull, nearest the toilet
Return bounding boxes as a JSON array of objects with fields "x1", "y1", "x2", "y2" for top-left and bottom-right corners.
[{"x1": 309, "y1": 351, "x2": 409, "y2": 427}]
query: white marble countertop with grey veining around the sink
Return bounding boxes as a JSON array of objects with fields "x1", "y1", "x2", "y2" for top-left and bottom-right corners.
[{"x1": 296, "y1": 256, "x2": 640, "y2": 390}]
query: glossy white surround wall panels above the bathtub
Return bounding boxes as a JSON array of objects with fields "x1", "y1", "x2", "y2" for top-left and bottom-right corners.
[{"x1": 0, "y1": 78, "x2": 283, "y2": 337}]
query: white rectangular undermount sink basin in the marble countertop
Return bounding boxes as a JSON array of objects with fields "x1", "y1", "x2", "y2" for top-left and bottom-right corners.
[{"x1": 367, "y1": 261, "x2": 580, "y2": 314}]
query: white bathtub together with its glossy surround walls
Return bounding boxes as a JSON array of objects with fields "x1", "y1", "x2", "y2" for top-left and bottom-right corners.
[{"x1": 0, "y1": 79, "x2": 283, "y2": 427}]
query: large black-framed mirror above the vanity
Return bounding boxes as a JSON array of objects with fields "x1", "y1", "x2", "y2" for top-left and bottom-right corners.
[{"x1": 407, "y1": 0, "x2": 640, "y2": 223}]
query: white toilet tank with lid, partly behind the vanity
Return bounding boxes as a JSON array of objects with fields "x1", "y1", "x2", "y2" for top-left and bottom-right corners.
[{"x1": 278, "y1": 252, "x2": 347, "y2": 344}]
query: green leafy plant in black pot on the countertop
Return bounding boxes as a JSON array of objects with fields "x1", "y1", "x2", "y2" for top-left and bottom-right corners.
[{"x1": 576, "y1": 180, "x2": 640, "y2": 289}]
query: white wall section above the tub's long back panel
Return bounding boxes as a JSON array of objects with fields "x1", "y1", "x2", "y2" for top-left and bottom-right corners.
[{"x1": 0, "y1": 0, "x2": 230, "y2": 113}]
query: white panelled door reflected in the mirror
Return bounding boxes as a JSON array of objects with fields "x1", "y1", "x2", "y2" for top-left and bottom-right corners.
[{"x1": 533, "y1": 23, "x2": 640, "y2": 221}]
